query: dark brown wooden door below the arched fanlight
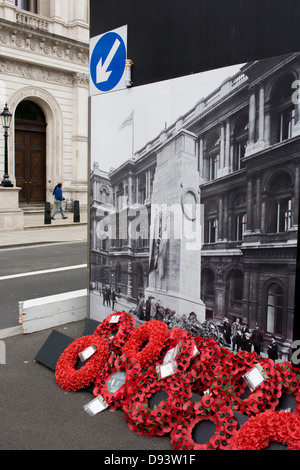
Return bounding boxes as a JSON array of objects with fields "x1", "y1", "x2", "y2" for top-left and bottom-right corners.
[{"x1": 15, "y1": 121, "x2": 46, "y2": 204}]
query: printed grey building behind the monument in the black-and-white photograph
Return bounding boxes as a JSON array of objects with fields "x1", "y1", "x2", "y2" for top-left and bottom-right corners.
[{"x1": 91, "y1": 53, "x2": 300, "y2": 357}]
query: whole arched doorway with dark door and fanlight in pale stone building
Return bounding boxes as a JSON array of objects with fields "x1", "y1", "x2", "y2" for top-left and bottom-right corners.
[{"x1": 15, "y1": 100, "x2": 46, "y2": 204}]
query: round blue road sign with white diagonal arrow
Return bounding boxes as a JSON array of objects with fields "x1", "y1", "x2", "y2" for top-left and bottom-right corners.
[{"x1": 90, "y1": 31, "x2": 127, "y2": 92}]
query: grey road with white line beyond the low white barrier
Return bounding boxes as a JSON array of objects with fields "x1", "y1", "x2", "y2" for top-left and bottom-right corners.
[{"x1": 0, "y1": 241, "x2": 88, "y2": 329}]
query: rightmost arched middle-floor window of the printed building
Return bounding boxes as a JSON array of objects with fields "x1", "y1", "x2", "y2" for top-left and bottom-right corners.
[{"x1": 268, "y1": 173, "x2": 292, "y2": 233}]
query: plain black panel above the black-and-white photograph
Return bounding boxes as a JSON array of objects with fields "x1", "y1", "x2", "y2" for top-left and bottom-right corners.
[{"x1": 90, "y1": 0, "x2": 300, "y2": 86}]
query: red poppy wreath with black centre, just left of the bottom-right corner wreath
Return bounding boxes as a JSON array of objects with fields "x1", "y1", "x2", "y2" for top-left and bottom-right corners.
[{"x1": 171, "y1": 395, "x2": 238, "y2": 450}]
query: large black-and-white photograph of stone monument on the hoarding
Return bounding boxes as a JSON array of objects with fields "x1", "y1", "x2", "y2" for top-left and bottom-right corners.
[{"x1": 89, "y1": 50, "x2": 300, "y2": 361}]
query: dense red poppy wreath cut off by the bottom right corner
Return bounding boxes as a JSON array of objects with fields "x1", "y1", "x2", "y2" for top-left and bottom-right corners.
[{"x1": 231, "y1": 410, "x2": 300, "y2": 450}]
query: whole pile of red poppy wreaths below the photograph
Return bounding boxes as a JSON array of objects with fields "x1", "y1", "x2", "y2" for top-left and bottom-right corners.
[{"x1": 55, "y1": 311, "x2": 300, "y2": 450}]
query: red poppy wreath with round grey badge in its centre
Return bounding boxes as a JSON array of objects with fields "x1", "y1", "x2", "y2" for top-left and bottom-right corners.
[{"x1": 93, "y1": 352, "x2": 141, "y2": 410}]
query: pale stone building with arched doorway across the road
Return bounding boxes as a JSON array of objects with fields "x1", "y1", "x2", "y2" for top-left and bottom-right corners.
[{"x1": 0, "y1": 0, "x2": 89, "y2": 207}]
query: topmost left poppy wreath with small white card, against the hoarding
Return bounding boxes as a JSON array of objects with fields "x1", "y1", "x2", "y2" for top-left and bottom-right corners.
[{"x1": 94, "y1": 311, "x2": 135, "y2": 353}]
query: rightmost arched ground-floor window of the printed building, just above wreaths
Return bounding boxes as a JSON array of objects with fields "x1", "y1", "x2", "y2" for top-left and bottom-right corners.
[{"x1": 267, "y1": 283, "x2": 284, "y2": 335}]
